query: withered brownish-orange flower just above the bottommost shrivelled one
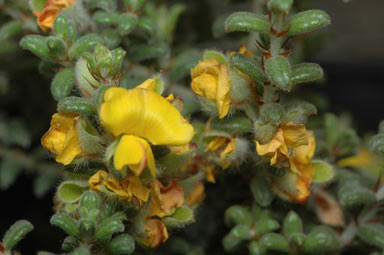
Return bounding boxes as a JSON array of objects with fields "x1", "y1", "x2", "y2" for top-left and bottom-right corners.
[{"x1": 148, "y1": 180, "x2": 184, "y2": 218}]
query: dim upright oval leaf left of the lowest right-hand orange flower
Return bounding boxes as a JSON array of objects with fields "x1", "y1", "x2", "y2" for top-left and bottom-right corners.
[{"x1": 250, "y1": 176, "x2": 274, "y2": 207}]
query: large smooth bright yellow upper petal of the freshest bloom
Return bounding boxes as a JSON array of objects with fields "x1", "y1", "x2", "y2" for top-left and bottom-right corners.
[{"x1": 99, "y1": 88, "x2": 193, "y2": 145}]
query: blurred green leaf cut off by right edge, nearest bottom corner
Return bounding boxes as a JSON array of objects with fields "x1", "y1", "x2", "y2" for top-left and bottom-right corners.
[{"x1": 358, "y1": 223, "x2": 384, "y2": 249}]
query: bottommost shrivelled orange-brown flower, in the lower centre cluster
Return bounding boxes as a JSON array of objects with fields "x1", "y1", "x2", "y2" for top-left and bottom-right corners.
[{"x1": 140, "y1": 218, "x2": 168, "y2": 248}]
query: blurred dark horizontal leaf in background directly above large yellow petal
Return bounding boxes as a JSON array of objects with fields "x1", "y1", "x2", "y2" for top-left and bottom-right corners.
[{"x1": 130, "y1": 43, "x2": 169, "y2": 62}]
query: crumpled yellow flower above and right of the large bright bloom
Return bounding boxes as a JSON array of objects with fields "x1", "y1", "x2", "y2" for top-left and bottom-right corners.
[{"x1": 191, "y1": 59, "x2": 231, "y2": 119}]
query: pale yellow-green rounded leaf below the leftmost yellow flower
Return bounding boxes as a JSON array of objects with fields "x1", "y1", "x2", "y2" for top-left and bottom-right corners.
[{"x1": 57, "y1": 181, "x2": 88, "y2": 203}]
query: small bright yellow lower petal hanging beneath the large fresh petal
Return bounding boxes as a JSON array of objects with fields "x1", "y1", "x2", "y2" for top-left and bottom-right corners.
[{"x1": 113, "y1": 135, "x2": 156, "y2": 176}]
